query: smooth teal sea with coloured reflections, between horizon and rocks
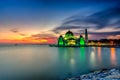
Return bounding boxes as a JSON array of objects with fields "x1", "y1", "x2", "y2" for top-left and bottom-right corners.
[{"x1": 0, "y1": 45, "x2": 120, "y2": 80}]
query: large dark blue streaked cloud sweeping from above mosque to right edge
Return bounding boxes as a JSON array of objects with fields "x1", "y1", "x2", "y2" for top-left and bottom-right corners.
[{"x1": 53, "y1": 5, "x2": 120, "y2": 34}]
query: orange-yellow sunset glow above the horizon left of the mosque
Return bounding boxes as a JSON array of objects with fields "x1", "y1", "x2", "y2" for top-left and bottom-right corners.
[{"x1": 0, "y1": 25, "x2": 56, "y2": 43}]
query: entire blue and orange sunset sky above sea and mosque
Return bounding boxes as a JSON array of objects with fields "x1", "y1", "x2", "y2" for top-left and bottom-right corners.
[{"x1": 0, "y1": 0, "x2": 120, "y2": 43}]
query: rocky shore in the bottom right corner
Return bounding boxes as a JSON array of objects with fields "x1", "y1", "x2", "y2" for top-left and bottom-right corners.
[{"x1": 66, "y1": 69, "x2": 120, "y2": 80}]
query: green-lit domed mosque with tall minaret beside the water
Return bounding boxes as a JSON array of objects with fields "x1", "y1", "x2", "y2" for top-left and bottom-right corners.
[{"x1": 58, "y1": 29, "x2": 88, "y2": 46}]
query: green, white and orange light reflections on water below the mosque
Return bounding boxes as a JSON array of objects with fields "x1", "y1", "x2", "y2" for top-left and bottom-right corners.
[{"x1": 58, "y1": 47, "x2": 118, "y2": 70}]
